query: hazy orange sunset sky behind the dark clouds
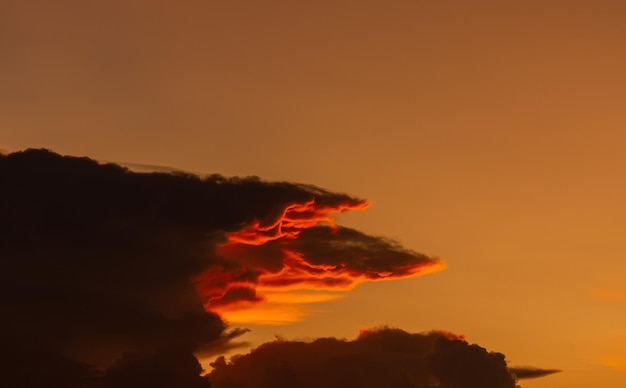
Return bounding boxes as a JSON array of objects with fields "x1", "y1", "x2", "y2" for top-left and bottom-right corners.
[{"x1": 0, "y1": 0, "x2": 626, "y2": 388}]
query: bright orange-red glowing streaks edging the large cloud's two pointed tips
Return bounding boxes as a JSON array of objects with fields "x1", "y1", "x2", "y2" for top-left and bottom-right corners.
[{"x1": 195, "y1": 199, "x2": 445, "y2": 325}]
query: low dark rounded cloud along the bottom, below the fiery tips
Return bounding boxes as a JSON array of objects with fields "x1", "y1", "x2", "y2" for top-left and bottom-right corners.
[{"x1": 209, "y1": 328, "x2": 552, "y2": 388}]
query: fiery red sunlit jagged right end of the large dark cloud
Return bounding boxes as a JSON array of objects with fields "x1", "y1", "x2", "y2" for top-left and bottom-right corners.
[{"x1": 195, "y1": 197, "x2": 444, "y2": 324}]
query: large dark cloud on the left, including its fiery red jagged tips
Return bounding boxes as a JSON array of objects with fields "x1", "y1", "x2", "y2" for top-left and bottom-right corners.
[{"x1": 0, "y1": 150, "x2": 442, "y2": 384}]
